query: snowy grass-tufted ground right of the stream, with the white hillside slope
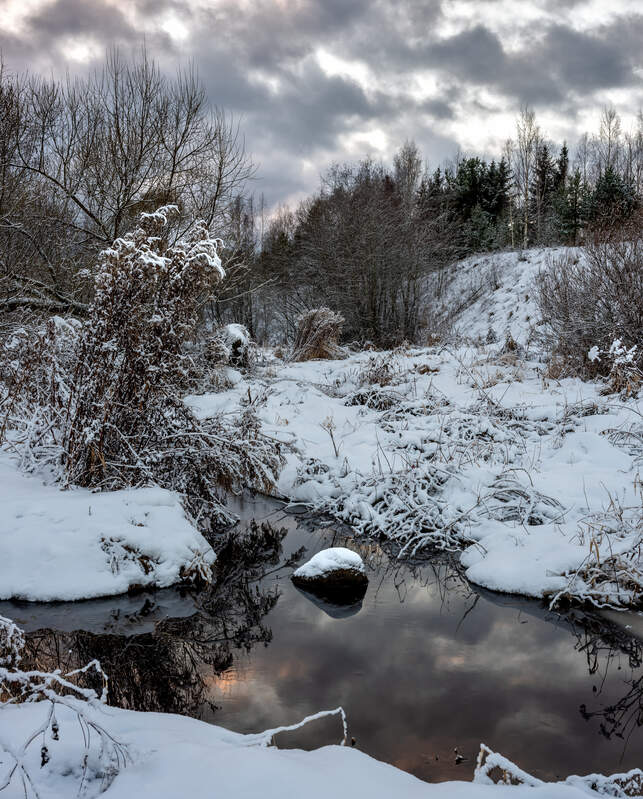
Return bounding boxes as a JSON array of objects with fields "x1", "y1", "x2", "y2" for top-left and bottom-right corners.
[{"x1": 186, "y1": 250, "x2": 643, "y2": 605}]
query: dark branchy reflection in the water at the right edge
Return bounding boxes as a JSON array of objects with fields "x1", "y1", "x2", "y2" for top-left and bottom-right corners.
[{"x1": 571, "y1": 614, "x2": 643, "y2": 741}]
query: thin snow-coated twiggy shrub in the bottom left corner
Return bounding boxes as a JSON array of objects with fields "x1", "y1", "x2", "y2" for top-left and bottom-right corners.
[{"x1": 0, "y1": 616, "x2": 130, "y2": 797}]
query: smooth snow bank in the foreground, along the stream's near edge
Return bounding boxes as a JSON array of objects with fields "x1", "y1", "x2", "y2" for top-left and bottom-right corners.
[{"x1": 0, "y1": 702, "x2": 616, "y2": 799}]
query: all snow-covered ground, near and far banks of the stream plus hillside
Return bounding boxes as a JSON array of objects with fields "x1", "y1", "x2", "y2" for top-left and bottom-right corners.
[{"x1": 0, "y1": 251, "x2": 643, "y2": 799}]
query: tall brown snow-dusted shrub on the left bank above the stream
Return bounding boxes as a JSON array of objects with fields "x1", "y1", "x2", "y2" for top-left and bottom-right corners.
[{"x1": 0, "y1": 206, "x2": 281, "y2": 519}]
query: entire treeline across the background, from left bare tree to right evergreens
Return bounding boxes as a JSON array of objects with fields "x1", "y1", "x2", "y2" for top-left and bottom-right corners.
[{"x1": 0, "y1": 52, "x2": 643, "y2": 346}]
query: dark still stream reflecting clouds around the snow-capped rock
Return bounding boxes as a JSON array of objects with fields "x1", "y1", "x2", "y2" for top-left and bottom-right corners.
[{"x1": 0, "y1": 497, "x2": 643, "y2": 781}]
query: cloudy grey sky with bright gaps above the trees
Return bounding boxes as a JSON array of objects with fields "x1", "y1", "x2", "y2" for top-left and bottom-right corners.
[{"x1": 0, "y1": 0, "x2": 643, "y2": 209}]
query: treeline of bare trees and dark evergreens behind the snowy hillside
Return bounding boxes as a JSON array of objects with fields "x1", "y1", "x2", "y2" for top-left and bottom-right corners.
[{"x1": 229, "y1": 108, "x2": 643, "y2": 346}]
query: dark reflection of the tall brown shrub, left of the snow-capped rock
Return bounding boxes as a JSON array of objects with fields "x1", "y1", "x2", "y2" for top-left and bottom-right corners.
[{"x1": 25, "y1": 522, "x2": 299, "y2": 715}]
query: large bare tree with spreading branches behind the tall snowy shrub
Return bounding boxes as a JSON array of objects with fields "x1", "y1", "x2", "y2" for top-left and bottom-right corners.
[{"x1": 0, "y1": 50, "x2": 253, "y2": 313}]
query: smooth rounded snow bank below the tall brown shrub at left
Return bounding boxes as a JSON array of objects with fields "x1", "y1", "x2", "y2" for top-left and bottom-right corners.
[{"x1": 0, "y1": 452, "x2": 215, "y2": 602}]
